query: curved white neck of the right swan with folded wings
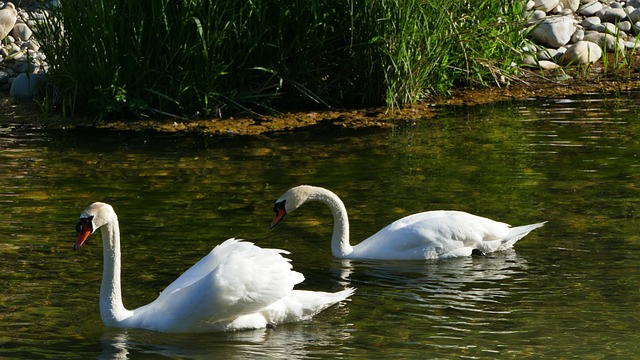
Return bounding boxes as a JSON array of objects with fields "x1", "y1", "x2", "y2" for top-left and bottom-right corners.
[{"x1": 308, "y1": 189, "x2": 353, "y2": 258}]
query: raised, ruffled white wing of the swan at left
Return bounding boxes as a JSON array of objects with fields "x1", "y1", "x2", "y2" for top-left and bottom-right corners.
[{"x1": 139, "y1": 239, "x2": 304, "y2": 331}]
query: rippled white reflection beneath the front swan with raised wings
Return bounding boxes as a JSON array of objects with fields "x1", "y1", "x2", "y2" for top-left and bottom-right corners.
[{"x1": 99, "y1": 306, "x2": 353, "y2": 360}]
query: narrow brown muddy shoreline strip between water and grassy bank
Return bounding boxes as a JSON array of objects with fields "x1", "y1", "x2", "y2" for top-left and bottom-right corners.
[{"x1": 0, "y1": 64, "x2": 640, "y2": 136}]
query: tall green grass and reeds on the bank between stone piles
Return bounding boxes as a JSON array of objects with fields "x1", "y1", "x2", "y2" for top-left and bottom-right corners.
[{"x1": 37, "y1": 0, "x2": 524, "y2": 121}]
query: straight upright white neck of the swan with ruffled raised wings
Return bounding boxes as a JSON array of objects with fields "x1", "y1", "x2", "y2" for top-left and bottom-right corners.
[{"x1": 100, "y1": 218, "x2": 130, "y2": 325}]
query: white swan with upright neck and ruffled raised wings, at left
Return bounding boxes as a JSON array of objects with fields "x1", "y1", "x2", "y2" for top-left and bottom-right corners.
[{"x1": 74, "y1": 202, "x2": 354, "y2": 332}]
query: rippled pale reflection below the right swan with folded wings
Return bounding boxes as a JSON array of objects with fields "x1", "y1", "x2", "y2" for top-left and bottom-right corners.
[{"x1": 332, "y1": 249, "x2": 528, "y2": 326}]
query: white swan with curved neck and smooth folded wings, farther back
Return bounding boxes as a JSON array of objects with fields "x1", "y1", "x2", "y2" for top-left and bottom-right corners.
[{"x1": 270, "y1": 185, "x2": 545, "y2": 260}]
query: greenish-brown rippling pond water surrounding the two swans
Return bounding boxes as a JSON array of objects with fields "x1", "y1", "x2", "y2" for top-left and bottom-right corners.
[{"x1": 0, "y1": 93, "x2": 640, "y2": 359}]
